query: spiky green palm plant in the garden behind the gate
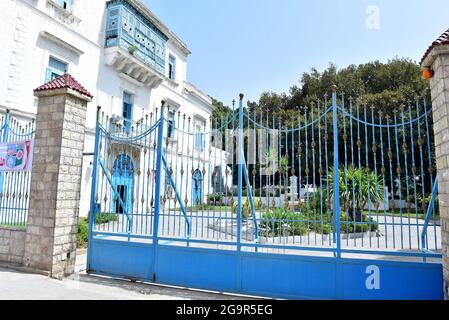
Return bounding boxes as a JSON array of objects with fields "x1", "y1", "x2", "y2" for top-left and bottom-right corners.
[{"x1": 327, "y1": 166, "x2": 384, "y2": 221}]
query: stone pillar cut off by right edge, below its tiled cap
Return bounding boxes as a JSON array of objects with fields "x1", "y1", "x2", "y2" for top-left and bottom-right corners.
[{"x1": 422, "y1": 45, "x2": 449, "y2": 299}]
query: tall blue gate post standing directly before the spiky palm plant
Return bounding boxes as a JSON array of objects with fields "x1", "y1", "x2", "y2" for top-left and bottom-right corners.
[{"x1": 332, "y1": 85, "x2": 341, "y2": 258}]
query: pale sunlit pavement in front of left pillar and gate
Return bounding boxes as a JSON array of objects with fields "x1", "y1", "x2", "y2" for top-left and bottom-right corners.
[{"x1": 0, "y1": 252, "x2": 250, "y2": 300}]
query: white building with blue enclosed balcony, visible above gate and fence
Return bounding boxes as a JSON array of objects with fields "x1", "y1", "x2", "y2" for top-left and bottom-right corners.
[{"x1": 0, "y1": 0, "x2": 228, "y2": 215}]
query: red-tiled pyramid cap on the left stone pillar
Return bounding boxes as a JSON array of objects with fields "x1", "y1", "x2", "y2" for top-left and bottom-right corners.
[{"x1": 34, "y1": 73, "x2": 93, "y2": 101}]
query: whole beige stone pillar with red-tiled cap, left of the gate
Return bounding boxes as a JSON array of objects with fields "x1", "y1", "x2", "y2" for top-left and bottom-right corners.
[{"x1": 23, "y1": 75, "x2": 92, "y2": 279}]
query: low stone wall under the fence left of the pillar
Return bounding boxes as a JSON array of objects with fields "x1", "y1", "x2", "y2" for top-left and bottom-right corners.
[{"x1": 0, "y1": 227, "x2": 26, "y2": 265}]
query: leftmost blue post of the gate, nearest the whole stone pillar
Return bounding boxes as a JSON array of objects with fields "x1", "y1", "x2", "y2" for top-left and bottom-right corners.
[{"x1": 87, "y1": 106, "x2": 101, "y2": 271}]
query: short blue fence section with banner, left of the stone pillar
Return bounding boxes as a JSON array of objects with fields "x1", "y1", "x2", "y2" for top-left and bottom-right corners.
[{"x1": 0, "y1": 111, "x2": 35, "y2": 227}]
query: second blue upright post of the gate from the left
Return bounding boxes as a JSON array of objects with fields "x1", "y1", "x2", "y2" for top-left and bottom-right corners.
[{"x1": 153, "y1": 101, "x2": 165, "y2": 282}]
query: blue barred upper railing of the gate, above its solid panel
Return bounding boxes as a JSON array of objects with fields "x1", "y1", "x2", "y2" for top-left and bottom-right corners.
[{"x1": 91, "y1": 92, "x2": 441, "y2": 257}]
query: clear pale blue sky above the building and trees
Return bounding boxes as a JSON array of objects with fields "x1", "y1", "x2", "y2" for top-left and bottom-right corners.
[{"x1": 143, "y1": 0, "x2": 449, "y2": 104}]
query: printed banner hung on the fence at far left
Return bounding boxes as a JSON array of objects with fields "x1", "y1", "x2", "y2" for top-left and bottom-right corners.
[{"x1": 0, "y1": 140, "x2": 34, "y2": 172}]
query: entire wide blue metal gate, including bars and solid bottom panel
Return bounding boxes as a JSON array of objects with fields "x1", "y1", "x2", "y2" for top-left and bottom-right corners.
[{"x1": 87, "y1": 91, "x2": 443, "y2": 299}]
